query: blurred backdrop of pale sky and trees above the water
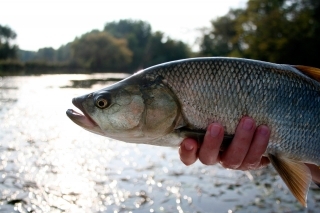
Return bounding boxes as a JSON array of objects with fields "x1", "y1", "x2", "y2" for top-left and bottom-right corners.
[{"x1": 0, "y1": 0, "x2": 320, "y2": 73}]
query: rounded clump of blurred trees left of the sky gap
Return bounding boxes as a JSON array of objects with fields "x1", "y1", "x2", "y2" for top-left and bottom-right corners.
[{"x1": 0, "y1": 19, "x2": 191, "y2": 73}]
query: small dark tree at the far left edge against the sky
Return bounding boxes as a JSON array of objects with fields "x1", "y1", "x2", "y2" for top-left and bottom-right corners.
[{"x1": 0, "y1": 25, "x2": 18, "y2": 60}]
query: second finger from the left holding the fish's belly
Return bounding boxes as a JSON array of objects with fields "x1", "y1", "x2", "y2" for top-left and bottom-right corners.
[{"x1": 199, "y1": 123, "x2": 224, "y2": 165}]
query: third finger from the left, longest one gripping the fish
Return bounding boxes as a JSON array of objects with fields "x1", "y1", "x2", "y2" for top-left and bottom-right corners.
[{"x1": 220, "y1": 117, "x2": 256, "y2": 169}]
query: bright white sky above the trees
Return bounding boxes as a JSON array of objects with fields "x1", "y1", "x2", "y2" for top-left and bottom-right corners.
[{"x1": 0, "y1": 0, "x2": 246, "y2": 51}]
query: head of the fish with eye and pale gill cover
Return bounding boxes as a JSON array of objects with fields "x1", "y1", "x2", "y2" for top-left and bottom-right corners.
[{"x1": 67, "y1": 76, "x2": 181, "y2": 146}]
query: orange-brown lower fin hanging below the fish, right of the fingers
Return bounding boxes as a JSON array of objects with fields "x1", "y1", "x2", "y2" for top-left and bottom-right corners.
[{"x1": 268, "y1": 154, "x2": 312, "y2": 207}]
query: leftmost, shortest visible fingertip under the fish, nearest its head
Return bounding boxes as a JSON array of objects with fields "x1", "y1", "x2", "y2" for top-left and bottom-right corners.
[{"x1": 179, "y1": 138, "x2": 198, "y2": 166}]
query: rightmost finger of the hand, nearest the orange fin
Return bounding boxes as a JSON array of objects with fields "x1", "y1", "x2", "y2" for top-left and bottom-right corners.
[{"x1": 238, "y1": 125, "x2": 270, "y2": 170}]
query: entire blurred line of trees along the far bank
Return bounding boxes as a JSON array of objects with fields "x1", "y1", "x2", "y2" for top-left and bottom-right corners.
[{"x1": 0, "y1": 0, "x2": 320, "y2": 72}]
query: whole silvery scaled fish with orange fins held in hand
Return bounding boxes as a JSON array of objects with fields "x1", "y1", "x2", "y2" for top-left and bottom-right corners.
[{"x1": 66, "y1": 57, "x2": 320, "y2": 207}]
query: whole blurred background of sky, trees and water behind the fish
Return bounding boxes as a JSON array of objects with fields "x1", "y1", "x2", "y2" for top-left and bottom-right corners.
[{"x1": 0, "y1": 0, "x2": 320, "y2": 213}]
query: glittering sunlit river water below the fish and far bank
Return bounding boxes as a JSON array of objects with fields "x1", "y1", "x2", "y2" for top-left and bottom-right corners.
[{"x1": 0, "y1": 74, "x2": 320, "y2": 213}]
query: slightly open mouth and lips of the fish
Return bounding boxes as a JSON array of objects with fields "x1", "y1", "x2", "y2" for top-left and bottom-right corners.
[{"x1": 66, "y1": 97, "x2": 98, "y2": 129}]
